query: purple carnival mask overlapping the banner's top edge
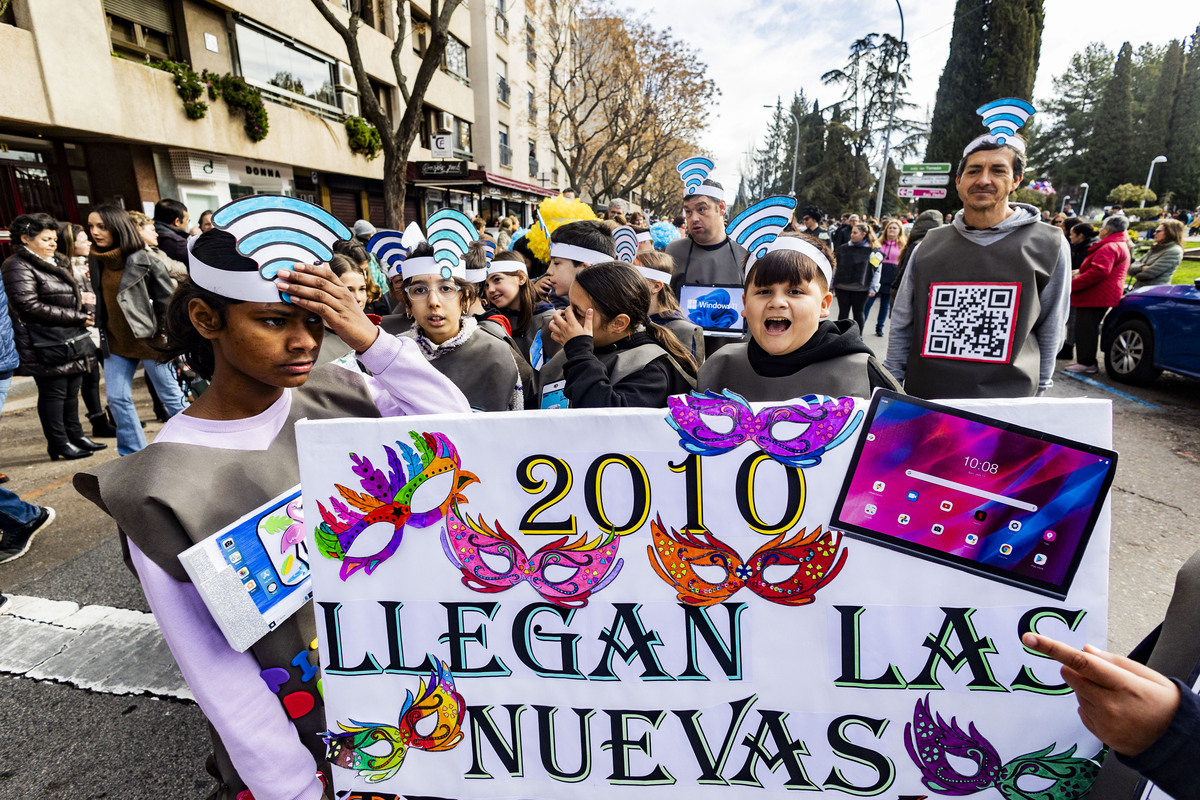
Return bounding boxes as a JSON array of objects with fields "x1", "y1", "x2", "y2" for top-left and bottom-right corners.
[{"x1": 667, "y1": 390, "x2": 863, "y2": 467}]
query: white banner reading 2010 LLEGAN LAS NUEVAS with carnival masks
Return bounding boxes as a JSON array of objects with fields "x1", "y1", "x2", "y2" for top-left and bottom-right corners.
[{"x1": 298, "y1": 399, "x2": 1111, "y2": 800}]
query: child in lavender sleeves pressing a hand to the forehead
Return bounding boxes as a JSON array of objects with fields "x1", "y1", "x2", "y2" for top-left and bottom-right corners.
[{"x1": 74, "y1": 221, "x2": 468, "y2": 800}]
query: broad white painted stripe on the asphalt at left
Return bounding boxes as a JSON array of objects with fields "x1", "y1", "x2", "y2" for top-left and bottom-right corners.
[{"x1": 0, "y1": 595, "x2": 193, "y2": 700}]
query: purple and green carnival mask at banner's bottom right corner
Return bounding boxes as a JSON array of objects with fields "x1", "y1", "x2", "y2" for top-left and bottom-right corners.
[{"x1": 904, "y1": 694, "x2": 1104, "y2": 800}]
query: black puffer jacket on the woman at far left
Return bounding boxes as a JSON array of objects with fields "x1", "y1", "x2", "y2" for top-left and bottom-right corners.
[{"x1": 0, "y1": 245, "x2": 96, "y2": 378}]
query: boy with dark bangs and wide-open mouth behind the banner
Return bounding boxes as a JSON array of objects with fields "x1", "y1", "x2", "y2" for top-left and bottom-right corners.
[{"x1": 696, "y1": 234, "x2": 899, "y2": 402}]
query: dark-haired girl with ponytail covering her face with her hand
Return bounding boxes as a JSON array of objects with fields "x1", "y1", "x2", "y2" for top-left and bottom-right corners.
[{"x1": 541, "y1": 261, "x2": 696, "y2": 408}]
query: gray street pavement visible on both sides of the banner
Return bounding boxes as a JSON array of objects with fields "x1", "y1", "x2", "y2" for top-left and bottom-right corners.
[{"x1": 0, "y1": 345, "x2": 1200, "y2": 800}]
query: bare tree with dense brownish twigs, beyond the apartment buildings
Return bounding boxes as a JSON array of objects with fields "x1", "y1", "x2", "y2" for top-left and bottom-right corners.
[{"x1": 539, "y1": 0, "x2": 720, "y2": 203}]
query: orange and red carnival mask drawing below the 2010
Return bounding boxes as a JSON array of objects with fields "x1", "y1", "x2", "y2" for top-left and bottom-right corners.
[{"x1": 646, "y1": 517, "x2": 847, "y2": 606}]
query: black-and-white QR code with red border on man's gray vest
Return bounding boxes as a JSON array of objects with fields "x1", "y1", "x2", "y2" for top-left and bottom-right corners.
[{"x1": 922, "y1": 283, "x2": 1021, "y2": 363}]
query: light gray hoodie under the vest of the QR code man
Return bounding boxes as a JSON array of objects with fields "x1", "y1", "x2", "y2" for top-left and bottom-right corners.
[{"x1": 883, "y1": 203, "x2": 1070, "y2": 395}]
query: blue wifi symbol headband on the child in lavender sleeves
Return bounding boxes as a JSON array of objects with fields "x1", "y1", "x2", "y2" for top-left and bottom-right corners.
[{"x1": 187, "y1": 194, "x2": 352, "y2": 302}]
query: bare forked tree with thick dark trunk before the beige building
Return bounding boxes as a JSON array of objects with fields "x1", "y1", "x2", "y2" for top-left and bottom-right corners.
[{"x1": 312, "y1": 0, "x2": 462, "y2": 229}]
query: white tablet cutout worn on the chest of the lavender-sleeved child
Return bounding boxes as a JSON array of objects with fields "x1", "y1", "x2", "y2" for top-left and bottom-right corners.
[{"x1": 179, "y1": 486, "x2": 312, "y2": 652}]
